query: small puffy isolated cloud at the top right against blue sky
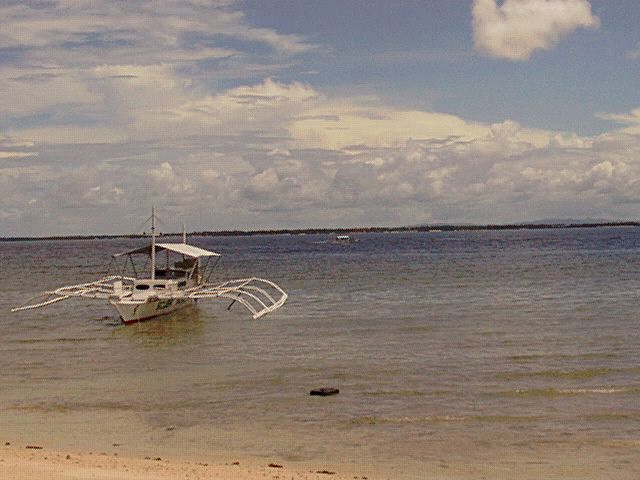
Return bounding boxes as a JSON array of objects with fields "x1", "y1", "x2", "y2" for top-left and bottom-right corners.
[{"x1": 472, "y1": 0, "x2": 600, "y2": 60}]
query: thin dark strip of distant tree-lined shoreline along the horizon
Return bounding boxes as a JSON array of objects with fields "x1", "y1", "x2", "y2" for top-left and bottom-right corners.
[{"x1": 0, "y1": 221, "x2": 640, "y2": 242}]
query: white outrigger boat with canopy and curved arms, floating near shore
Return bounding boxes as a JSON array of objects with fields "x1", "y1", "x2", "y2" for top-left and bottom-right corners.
[{"x1": 11, "y1": 209, "x2": 287, "y2": 324}]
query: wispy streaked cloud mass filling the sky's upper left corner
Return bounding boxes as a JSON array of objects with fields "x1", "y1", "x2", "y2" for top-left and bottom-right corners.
[{"x1": 0, "y1": 0, "x2": 315, "y2": 143}]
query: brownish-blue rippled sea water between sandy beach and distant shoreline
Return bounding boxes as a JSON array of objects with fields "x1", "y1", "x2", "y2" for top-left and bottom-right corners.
[{"x1": 0, "y1": 228, "x2": 640, "y2": 478}]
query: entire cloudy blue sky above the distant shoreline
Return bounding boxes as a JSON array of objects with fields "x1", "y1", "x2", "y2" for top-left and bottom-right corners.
[{"x1": 0, "y1": 0, "x2": 640, "y2": 236}]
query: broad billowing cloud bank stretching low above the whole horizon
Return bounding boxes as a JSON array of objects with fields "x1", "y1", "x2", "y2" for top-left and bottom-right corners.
[{"x1": 8, "y1": 71, "x2": 640, "y2": 233}]
